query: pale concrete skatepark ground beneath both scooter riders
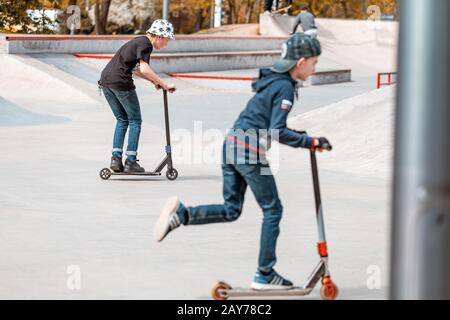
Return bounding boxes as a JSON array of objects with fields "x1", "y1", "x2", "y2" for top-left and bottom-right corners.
[{"x1": 0, "y1": 20, "x2": 395, "y2": 299}]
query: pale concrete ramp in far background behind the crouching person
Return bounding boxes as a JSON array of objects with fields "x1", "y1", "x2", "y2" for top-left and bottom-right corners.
[{"x1": 260, "y1": 15, "x2": 398, "y2": 74}]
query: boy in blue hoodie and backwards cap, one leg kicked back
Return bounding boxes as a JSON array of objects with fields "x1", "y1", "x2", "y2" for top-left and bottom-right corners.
[{"x1": 154, "y1": 33, "x2": 328, "y2": 290}]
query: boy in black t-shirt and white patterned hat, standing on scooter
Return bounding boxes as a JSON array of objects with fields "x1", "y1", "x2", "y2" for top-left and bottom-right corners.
[{"x1": 98, "y1": 20, "x2": 176, "y2": 173}]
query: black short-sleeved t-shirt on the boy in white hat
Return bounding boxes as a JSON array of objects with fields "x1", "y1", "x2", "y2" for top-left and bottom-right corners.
[{"x1": 99, "y1": 36, "x2": 153, "y2": 91}]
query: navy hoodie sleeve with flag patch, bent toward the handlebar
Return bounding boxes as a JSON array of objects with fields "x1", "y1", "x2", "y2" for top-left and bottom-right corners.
[{"x1": 270, "y1": 84, "x2": 313, "y2": 148}]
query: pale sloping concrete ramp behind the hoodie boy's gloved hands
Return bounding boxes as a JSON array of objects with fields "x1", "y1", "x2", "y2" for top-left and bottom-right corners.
[{"x1": 288, "y1": 86, "x2": 396, "y2": 178}]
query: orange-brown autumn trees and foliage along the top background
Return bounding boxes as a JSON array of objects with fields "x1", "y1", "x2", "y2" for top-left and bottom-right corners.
[{"x1": 0, "y1": 0, "x2": 398, "y2": 34}]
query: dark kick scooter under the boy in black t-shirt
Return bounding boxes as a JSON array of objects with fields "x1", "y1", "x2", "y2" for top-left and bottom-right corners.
[{"x1": 100, "y1": 90, "x2": 178, "y2": 180}]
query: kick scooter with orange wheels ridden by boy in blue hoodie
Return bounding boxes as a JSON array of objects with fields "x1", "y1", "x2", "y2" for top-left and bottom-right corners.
[{"x1": 211, "y1": 145, "x2": 339, "y2": 300}]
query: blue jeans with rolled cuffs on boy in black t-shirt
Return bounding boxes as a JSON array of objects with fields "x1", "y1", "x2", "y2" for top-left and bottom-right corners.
[{"x1": 102, "y1": 87, "x2": 142, "y2": 156}]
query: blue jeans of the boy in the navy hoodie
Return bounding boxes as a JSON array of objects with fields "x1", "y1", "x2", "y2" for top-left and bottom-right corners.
[{"x1": 177, "y1": 152, "x2": 283, "y2": 273}]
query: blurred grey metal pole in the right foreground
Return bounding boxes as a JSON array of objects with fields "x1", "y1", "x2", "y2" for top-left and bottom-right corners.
[{"x1": 390, "y1": 0, "x2": 450, "y2": 299}]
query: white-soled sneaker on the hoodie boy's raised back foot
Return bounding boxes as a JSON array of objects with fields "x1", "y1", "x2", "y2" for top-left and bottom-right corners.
[{"x1": 153, "y1": 197, "x2": 181, "y2": 241}]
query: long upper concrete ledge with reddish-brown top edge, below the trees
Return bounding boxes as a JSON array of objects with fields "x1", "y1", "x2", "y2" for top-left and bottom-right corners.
[{"x1": 0, "y1": 35, "x2": 286, "y2": 54}]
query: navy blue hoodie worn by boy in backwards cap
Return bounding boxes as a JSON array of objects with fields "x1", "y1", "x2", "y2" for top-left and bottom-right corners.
[{"x1": 227, "y1": 68, "x2": 313, "y2": 158}]
